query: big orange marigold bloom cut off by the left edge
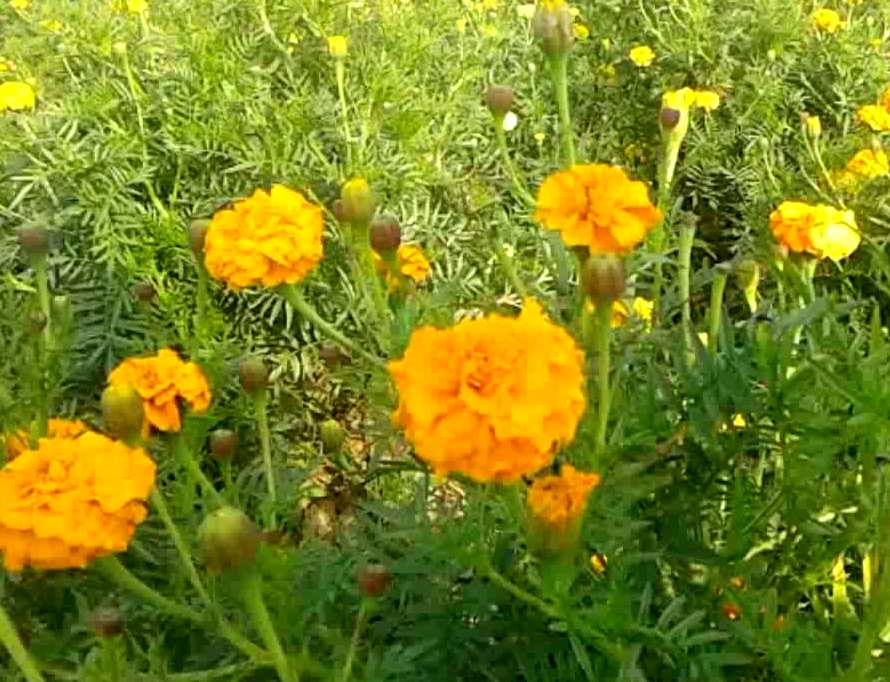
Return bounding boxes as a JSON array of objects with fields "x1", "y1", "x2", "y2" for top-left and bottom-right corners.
[{"x1": 0, "y1": 431, "x2": 155, "y2": 571}]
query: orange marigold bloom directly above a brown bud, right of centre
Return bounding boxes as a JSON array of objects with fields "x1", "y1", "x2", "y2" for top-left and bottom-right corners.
[{"x1": 535, "y1": 163, "x2": 661, "y2": 254}]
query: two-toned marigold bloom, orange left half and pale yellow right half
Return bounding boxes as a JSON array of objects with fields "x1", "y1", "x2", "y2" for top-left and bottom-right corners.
[{"x1": 769, "y1": 201, "x2": 861, "y2": 261}]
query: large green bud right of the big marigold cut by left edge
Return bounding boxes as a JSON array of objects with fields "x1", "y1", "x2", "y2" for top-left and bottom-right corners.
[{"x1": 198, "y1": 507, "x2": 260, "y2": 573}]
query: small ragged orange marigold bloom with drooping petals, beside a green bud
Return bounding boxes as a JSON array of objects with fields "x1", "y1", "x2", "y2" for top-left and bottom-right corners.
[{"x1": 108, "y1": 348, "x2": 210, "y2": 431}]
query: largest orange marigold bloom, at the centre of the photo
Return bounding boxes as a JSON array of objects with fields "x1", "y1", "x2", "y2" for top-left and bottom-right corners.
[{"x1": 389, "y1": 299, "x2": 584, "y2": 483}]
